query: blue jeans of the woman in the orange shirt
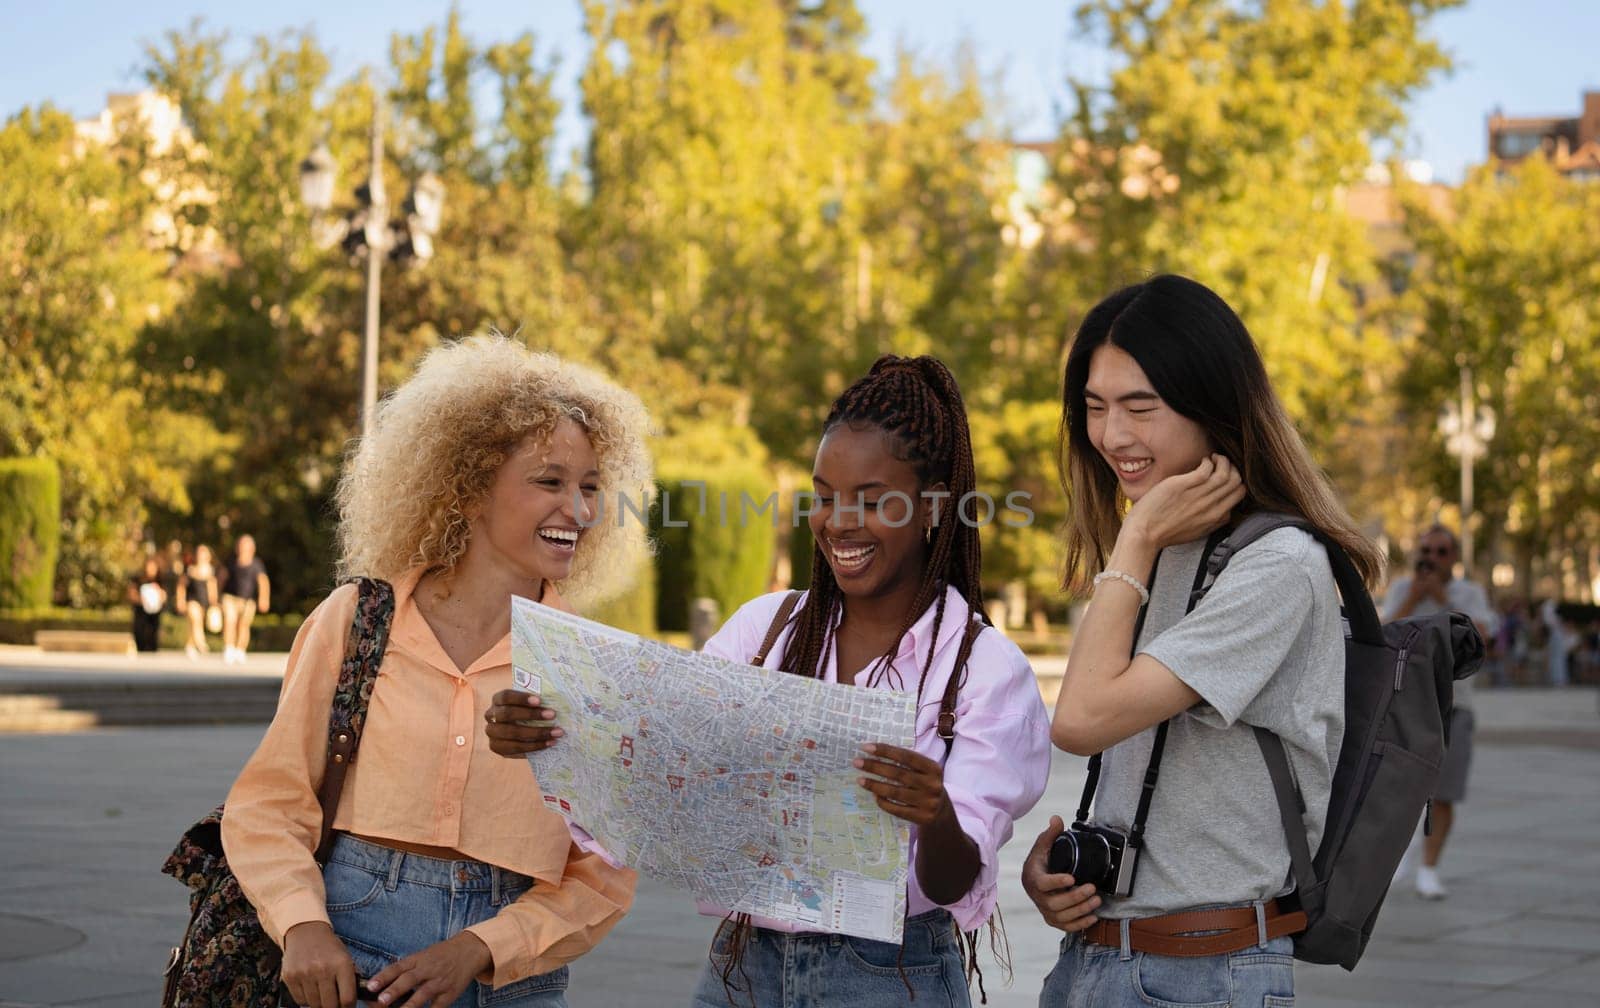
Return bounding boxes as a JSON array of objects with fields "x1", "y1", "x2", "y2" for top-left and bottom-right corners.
[{"x1": 322, "y1": 834, "x2": 566, "y2": 1008}]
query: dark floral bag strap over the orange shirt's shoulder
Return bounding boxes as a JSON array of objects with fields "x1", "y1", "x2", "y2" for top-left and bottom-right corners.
[{"x1": 317, "y1": 578, "x2": 395, "y2": 864}]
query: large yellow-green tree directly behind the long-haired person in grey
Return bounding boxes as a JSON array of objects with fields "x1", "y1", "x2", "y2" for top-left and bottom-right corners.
[{"x1": 1027, "y1": 0, "x2": 1458, "y2": 512}]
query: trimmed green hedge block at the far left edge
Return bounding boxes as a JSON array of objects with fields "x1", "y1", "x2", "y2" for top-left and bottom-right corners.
[{"x1": 0, "y1": 459, "x2": 61, "y2": 608}]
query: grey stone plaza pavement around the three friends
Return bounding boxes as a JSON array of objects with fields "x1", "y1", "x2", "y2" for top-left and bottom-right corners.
[{"x1": 0, "y1": 688, "x2": 1600, "y2": 1008}]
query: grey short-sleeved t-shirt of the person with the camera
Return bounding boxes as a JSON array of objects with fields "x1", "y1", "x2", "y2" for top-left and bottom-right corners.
[{"x1": 1094, "y1": 528, "x2": 1344, "y2": 917}]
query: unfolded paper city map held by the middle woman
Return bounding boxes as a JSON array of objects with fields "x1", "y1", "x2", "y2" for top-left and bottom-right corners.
[{"x1": 512, "y1": 598, "x2": 915, "y2": 944}]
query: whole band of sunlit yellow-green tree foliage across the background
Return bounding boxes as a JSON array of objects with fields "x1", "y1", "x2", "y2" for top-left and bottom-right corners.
[{"x1": 18, "y1": 0, "x2": 1600, "y2": 626}]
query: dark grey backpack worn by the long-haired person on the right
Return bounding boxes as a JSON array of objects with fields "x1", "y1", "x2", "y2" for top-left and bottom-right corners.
[{"x1": 1190, "y1": 512, "x2": 1483, "y2": 970}]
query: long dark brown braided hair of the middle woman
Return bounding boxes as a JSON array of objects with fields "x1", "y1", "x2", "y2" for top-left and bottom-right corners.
[{"x1": 778, "y1": 355, "x2": 982, "y2": 696}]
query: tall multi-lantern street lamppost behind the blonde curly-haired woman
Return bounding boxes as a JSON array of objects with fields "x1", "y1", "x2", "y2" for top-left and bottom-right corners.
[{"x1": 299, "y1": 88, "x2": 445, "y2": 438}]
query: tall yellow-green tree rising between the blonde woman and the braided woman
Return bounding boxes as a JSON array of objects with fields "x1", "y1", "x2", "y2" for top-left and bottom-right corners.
[{"x1": 566, "y1": 0, "x2": 870, "y2": 454}]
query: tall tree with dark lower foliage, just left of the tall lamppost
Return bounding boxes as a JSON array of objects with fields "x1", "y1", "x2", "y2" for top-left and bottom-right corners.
[{"x1": 146, "y1": 22, "x2": 360, "y2": 608}]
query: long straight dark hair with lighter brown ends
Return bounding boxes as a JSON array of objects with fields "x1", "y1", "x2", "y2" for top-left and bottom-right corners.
[{"x1": 1058, "y1": 274, "x2": 1384, "y2": 595}]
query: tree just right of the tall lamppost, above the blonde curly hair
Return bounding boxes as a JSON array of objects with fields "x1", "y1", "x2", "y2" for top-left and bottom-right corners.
[{"x1": 384, "y1": 10, "x2": 601, "y2": 382}]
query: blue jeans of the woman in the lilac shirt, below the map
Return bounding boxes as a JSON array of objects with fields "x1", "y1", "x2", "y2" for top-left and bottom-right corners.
[{"x1": 693, "y1": 910, "x2": 971, "y2": 1008}]
